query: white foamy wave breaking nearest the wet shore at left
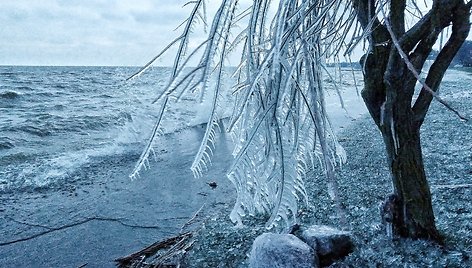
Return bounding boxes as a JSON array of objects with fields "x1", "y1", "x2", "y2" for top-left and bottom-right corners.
[{"x1": 0, "y1": 147, "x2": 139, "y2": 194}]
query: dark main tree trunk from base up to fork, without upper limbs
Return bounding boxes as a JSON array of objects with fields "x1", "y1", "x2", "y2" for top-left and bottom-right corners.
[{"x1": 362, "y1": 47, "x2": 441, "y2": 242}]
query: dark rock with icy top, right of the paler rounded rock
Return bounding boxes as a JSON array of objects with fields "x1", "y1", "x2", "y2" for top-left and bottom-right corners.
[{"x1": 297, "y1": 225, "x2": 354, "y2": 266}]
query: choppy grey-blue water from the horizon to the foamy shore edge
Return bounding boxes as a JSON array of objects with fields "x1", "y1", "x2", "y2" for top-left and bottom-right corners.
[{"x1": 0, "y1": 66, "x2": 229, "y2": 193}]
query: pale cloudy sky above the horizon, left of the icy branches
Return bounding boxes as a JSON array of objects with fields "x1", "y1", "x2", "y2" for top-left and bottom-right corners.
[{"x1": 0, "y1": 0, "x2": 470, "y2": 66}]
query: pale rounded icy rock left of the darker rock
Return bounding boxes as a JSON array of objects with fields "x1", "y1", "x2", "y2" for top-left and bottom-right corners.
[{"x1": 249, "y1": 233, "x2": 319, "y2": 268}]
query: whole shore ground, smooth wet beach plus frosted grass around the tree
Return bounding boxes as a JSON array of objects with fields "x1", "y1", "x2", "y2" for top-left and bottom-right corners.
[{"x1": 0, "y1": 71, "x2": 472, "y2": 267}]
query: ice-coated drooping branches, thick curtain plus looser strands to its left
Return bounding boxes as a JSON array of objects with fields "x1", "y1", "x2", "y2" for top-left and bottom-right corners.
[{"x1": 130, "y1": 0, "x2": 354, "y2": 228}]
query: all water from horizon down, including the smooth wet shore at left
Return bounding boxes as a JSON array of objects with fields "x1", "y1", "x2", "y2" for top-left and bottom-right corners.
[{"x1": 0, "y1": 66, "x2": 365, "y2": 267}]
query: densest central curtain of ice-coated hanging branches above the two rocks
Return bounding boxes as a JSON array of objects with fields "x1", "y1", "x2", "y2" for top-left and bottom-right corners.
[{"x1": 228, "y1": 1, "x2": 352, "y2": 228}]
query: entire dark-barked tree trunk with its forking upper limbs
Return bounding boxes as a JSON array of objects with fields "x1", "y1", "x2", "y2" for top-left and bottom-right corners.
[{"x1": 351, "y1": 0, "x2": 472, "y2": 241}]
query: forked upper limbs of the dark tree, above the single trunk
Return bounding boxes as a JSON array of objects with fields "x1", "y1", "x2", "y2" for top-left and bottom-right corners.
[{"x1": 352, "y1": 0, "x2": 472, "y2": 126}]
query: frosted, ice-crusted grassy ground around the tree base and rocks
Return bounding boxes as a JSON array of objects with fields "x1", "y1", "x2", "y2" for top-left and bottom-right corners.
[{"x1": 185, "y1": 71, "x2": 472, "y2": 267}]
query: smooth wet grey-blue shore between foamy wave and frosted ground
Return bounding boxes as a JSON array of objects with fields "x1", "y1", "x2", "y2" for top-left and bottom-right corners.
[{"x1": 0, "y1": 122, "x2": 238, "y2": 267}]
